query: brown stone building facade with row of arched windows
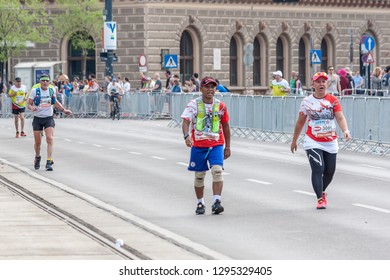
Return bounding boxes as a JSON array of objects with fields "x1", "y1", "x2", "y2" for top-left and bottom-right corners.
[{"x1": 10, "y1": 0, "x2": 390, "y2": 91}]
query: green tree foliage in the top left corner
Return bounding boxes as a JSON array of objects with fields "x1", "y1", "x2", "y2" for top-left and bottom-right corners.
[{"x1": 0, "y1": 0, "x2": 49, "y2": 78}]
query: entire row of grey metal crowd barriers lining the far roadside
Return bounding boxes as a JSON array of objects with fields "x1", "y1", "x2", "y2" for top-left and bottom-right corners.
[{"x1": 0, "y1": 91, "x2": 390, "y2": 155}]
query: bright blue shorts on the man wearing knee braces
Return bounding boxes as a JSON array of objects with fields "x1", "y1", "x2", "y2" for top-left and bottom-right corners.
[{"x1": 188, "y1": 145, "x2": 223, "y2": 172}]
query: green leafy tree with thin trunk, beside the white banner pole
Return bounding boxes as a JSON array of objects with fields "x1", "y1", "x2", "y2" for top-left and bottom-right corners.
[{"x1": 53, "y1": 0, "x2": 103, "y2": 78}]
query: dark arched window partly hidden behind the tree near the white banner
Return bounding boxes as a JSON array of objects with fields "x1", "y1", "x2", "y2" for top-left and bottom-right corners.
[{"x1": 68, "y1": 34, "x2": 96, "y2": 80}]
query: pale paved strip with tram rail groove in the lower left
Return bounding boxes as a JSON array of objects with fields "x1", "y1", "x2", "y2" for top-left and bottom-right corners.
[{"x1": 0, "y1": 159, "x2": 228, "y2": 260}]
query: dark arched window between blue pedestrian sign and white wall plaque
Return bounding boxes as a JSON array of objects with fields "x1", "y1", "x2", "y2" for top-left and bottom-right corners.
[{"x1": 180, "y1": 31, "x2": 194, "y2": 82}]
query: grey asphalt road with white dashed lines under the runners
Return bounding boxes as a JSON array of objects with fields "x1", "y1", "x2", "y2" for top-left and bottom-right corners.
[{"x1": 0, "y1": 119, "x2": 390, "y2": 260}]
